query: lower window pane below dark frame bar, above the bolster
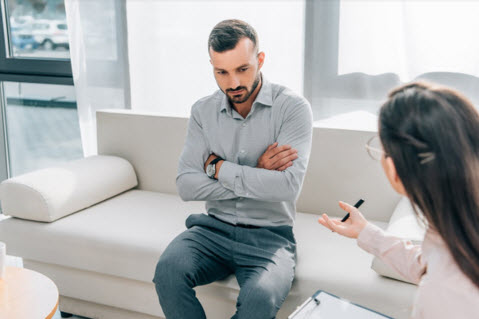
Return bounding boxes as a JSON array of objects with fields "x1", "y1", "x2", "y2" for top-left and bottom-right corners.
[{"x1": 3, "y1": 82, "x2": 83, "y2": 176}]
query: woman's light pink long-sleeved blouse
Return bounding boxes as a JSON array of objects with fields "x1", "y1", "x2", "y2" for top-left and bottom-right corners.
[{"x1": 358, "y1": 223, "x2": 479, "y2": 319}]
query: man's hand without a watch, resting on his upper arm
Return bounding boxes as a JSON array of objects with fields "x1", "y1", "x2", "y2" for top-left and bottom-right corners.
[{"x1": 256, "y1": 142, "x2": 298, "y2": 171}]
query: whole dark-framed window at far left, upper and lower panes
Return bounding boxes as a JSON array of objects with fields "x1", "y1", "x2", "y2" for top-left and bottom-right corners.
[{"x1": 0, "y1": 0, "x2": 83, "y2": 180}]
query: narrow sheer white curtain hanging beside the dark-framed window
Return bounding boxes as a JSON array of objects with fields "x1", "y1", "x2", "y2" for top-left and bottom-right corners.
[{"x1": 65, "y1": 0, "x2": 130, "y2": 156}]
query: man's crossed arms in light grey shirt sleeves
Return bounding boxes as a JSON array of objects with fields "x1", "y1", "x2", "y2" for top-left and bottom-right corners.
[{"x1": 177, "y1": 101, "x2": 312, "y2": 202}]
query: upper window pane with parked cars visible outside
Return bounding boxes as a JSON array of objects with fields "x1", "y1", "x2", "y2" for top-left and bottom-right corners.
[{"x1": 6, "y1": 0, "x2": 70, "y2": 59}]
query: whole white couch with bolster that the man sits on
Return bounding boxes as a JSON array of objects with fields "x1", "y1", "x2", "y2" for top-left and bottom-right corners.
[{"x1": 0, "y1": 110, "x2": 416, "y2": 319}]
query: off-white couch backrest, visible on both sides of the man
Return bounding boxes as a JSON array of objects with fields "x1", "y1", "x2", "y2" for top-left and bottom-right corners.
[{"x1": 97, "y1": 110, "x2": 399, "y2": 221}]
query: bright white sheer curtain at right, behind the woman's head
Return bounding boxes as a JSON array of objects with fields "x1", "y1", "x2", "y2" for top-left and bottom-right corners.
[{"x1": 305, "y1": 0, "x2": 479, "y2": 124}]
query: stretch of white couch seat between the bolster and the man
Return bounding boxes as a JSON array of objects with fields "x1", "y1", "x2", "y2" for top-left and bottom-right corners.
[{"x1": 0, "y1": 190, "x2": 199, "y2": 281}]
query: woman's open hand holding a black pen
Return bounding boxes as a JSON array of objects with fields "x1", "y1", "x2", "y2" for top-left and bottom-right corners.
[{"x1": 318, "y1": 202, "x2": 368, "y2": 238}]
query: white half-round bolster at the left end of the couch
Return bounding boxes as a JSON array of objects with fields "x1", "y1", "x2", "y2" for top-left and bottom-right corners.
[{"x1": 0, "y1": 155, "x2": 138, "y2": 222}]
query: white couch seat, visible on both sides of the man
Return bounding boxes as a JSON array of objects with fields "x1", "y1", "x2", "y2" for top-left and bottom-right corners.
[{"x1": 0, "y1": 190, "x2": 415, "y2": 313}]
